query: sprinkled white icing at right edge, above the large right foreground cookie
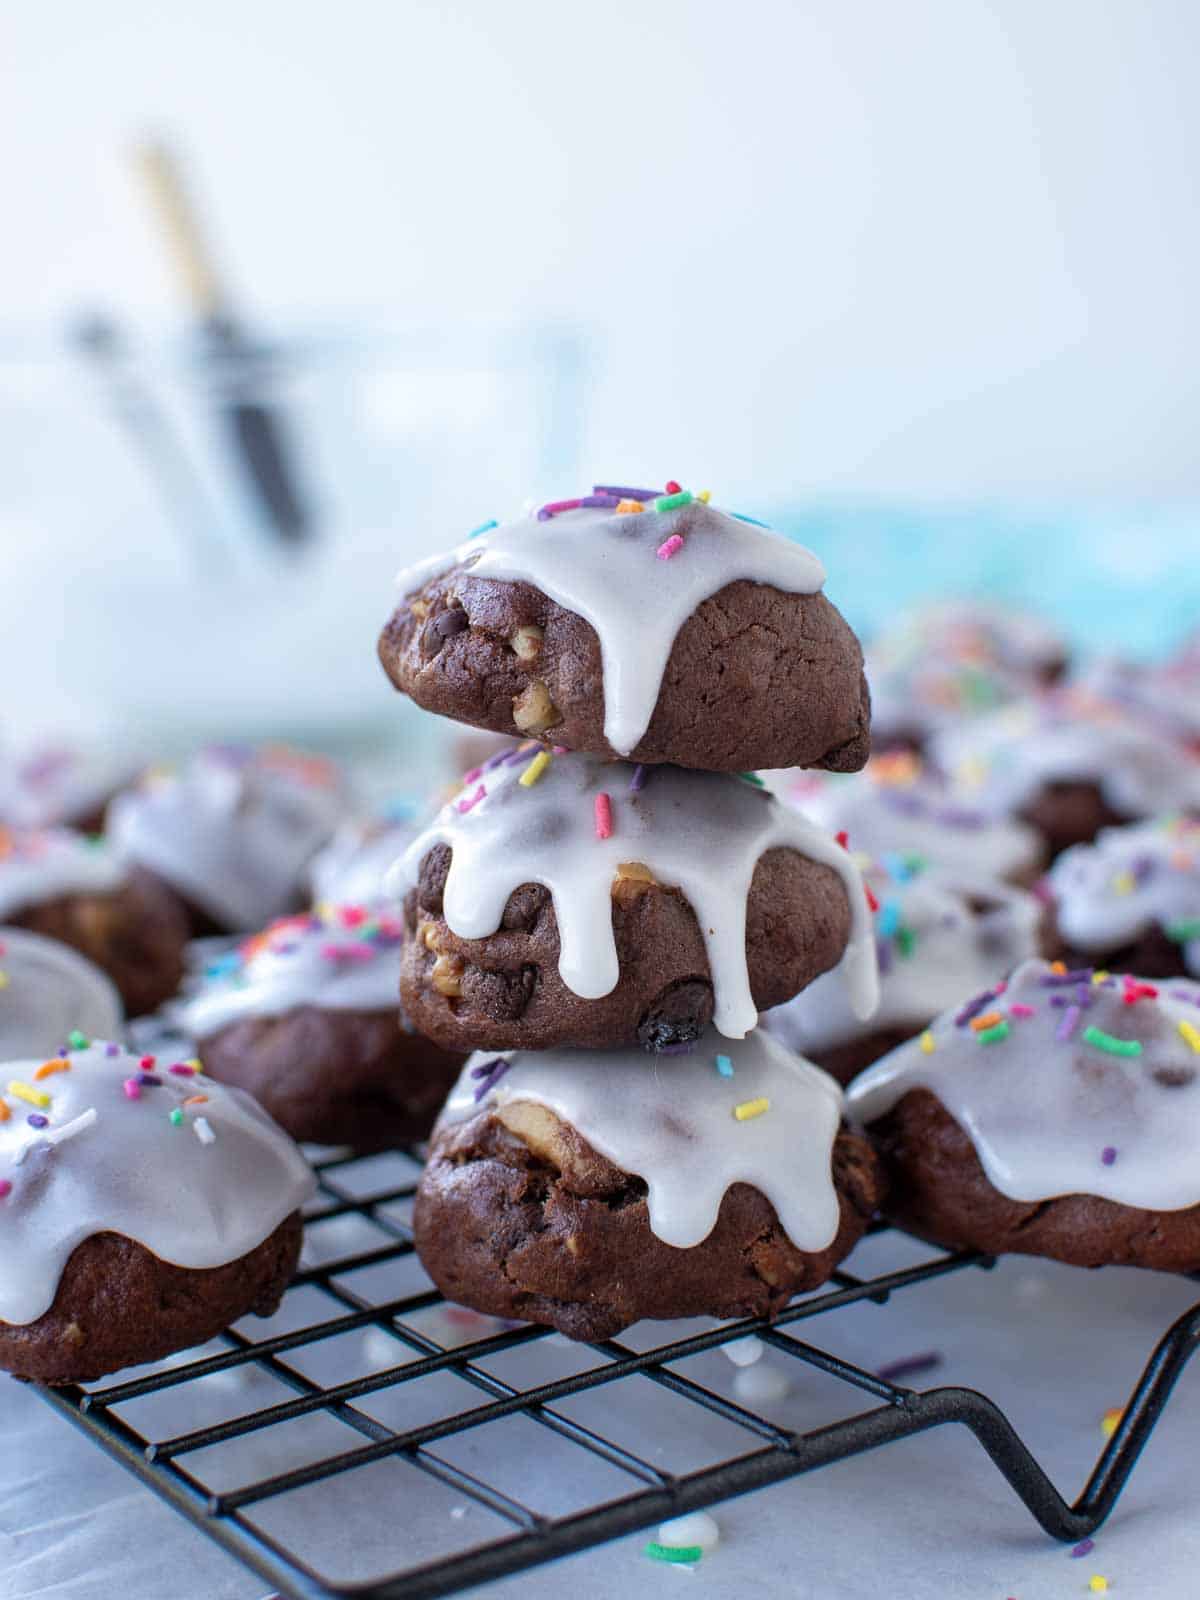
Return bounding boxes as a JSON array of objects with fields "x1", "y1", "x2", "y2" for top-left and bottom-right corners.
[{"x1": 1046, "y1": 816, "x2": 1200, "y2": 978}]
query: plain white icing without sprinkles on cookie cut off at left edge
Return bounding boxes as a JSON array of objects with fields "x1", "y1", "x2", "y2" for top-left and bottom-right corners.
[{"x1": 0, "y1": 928, "x2": 123, "y2": 1061}]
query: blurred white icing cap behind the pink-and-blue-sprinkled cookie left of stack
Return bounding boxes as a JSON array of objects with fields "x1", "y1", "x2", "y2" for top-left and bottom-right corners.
[{"x1": 109, "y1": 744, "x2": 349, "y2": 930}]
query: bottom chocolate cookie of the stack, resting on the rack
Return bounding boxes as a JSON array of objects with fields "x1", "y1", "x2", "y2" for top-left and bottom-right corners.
[{"x1": 413, "y1": 1034, "x2": 882, "y2": 1339}]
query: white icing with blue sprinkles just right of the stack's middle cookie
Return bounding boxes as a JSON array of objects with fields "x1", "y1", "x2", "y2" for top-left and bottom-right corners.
[{"x1": 763, "y1": 854, "x2": 1042, "y2": 1054}]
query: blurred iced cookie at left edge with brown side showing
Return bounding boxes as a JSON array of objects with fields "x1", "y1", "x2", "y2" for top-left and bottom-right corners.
[{"x1": 0, "y1": 829, "x2": 187, "y2": 1016}]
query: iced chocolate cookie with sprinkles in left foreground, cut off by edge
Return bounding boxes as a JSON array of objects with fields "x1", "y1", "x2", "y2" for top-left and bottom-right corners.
[{"x1": 0, "y1": 1038, "x2": 314, "y2": 1384}]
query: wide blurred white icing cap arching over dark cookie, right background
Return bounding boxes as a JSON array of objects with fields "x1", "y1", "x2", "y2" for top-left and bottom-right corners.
[{"x1": 931, "y1": 690, "x2": 1200, "y2": 816}]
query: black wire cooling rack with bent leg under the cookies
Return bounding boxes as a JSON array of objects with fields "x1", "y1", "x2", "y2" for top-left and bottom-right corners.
[{"x1": 32, "y1": 1157, "x2": 1200, "y2": 1600}]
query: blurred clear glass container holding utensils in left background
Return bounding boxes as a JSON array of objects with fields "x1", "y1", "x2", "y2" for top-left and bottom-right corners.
[{"x1": 0, "y1": 318, "x2": 584, "y2": 750}]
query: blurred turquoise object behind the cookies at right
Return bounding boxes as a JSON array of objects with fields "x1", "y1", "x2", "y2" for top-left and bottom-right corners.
[{"x1": 771, "y1": 501, "x2": 1200, "y2": 658}]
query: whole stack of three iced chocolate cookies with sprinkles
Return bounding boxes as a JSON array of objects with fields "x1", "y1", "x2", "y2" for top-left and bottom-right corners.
[{"x1": 379, "y1": 483, "x2": 882, "y2": 1339}]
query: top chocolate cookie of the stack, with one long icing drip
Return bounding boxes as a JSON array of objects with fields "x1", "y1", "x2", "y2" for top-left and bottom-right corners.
[{"x1": 379, "y1": 496, "x2": 870, "y2": 771}]
